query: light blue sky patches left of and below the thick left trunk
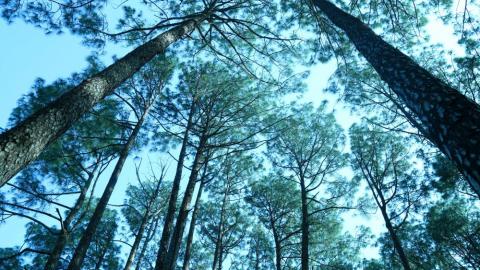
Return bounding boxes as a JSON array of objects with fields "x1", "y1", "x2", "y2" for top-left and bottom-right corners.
[{"x1": 0, "y1": 20, "x2": 132, "y2": 247}]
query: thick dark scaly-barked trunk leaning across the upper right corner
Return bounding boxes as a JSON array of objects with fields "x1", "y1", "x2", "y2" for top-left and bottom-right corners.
[{"x1": 312, "y1": 0, "x2": 480, "y2": 196}]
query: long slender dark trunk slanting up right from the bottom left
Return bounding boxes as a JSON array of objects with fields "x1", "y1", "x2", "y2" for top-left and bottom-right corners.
[{"x1": 67, "y1": 104, "x2": 151, "y2": 270}]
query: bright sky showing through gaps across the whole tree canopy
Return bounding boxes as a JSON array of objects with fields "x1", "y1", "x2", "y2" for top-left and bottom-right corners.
[{"x1": 0, "y1": 6, "x2": 461, "y2": 262}]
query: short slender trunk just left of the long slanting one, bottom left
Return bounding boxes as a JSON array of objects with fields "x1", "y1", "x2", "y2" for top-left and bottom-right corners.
[{"x1": 45, "y1": 168, "x2": 96, "y2": 270}]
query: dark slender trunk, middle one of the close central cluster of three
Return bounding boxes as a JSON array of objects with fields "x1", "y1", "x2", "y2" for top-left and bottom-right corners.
[{"x1": 162, "y1": 135, "x2": 206, "y2": 270}]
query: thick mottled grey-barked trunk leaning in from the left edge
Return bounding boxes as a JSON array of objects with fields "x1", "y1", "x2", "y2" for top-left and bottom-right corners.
[{"x1": 0, "y1": 18, "x2": 203, "y2": 186}]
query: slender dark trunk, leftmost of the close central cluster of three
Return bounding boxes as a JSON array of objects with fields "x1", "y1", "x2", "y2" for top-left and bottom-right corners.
[{"x1": 155, "y1": 101, "x2": 195, "y2": 270}]
